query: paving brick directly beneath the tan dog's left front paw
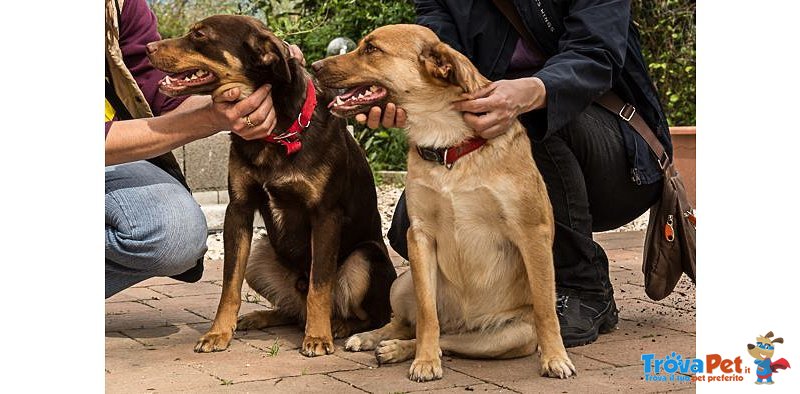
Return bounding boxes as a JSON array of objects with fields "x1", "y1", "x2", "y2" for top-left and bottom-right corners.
[{"x1": 329, "y1": 360, "x2": 483, "y2": 393}]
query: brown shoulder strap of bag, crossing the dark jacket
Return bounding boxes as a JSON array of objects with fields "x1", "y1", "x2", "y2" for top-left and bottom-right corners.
[{"x1": 492, "y1": 0, "x2": 670, "y2": 170}]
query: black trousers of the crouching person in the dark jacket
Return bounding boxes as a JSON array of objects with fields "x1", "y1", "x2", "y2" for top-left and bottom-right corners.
[{"x1": 388, "y1": 104, "x2": 662, "y2": 297}]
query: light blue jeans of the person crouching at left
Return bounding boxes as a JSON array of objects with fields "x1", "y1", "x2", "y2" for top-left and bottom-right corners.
[{"x1": 105, "y1": 161, "x2": 208, "y2": 298}]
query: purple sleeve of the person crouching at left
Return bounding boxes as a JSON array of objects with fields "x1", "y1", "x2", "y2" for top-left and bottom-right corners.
[{"x1": 119, "y1": 0, "x2": 186, "y2": 116}]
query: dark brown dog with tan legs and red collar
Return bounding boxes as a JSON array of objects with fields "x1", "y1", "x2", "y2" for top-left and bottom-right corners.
[{"x1": 148, "y1": 15, "x2": 396, "y2": 356}]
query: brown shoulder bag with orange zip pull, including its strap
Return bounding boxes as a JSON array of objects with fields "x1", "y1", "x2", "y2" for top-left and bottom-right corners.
[{"x1": 493, "y1": 0, "x2": 696, "y2": 301}]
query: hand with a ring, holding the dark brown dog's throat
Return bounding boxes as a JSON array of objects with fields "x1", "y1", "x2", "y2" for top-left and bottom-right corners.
[{"x1": 211, "y1": 85, "x2": 277, "y2": 140}]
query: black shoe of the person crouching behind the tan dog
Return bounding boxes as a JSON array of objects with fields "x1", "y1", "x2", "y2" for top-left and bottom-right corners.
[{"x1": 556, "y1": 289, "x2": 619, "y2": 347}]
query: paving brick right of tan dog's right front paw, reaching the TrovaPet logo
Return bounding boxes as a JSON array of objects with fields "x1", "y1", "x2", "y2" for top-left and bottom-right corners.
[{"x1": 571, "y1": 333, "x2": 696, "y2": 367}]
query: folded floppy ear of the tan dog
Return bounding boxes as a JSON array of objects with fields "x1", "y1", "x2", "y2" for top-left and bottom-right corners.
[{"x1": 419, "y1": 42, "x2": 483, "y2": 92}]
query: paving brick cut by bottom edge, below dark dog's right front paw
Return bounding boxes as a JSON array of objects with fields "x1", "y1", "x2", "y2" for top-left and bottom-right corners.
[{"x1": 230, "y1": 375, "x2": 363, "y2": 394}]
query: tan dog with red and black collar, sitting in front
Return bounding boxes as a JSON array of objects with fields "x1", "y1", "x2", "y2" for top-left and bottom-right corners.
[{"x1": 313, "y1": 25, "x2": 575, "y2": 381}]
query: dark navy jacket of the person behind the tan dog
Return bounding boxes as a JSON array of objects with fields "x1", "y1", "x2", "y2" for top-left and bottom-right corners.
[{"x1": 415, "y1": 0, "x2": 672, "y2": 184}]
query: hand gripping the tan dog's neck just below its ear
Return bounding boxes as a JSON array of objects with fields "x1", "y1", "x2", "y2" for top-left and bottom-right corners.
[{"x1": 453, "y1": 77, "x2": 547, "y2": 139}]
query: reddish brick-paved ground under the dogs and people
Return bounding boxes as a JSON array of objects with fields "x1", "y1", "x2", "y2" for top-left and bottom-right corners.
[{"x1": 105, "y1": 232, "x2": 695, "y2": 393}]
